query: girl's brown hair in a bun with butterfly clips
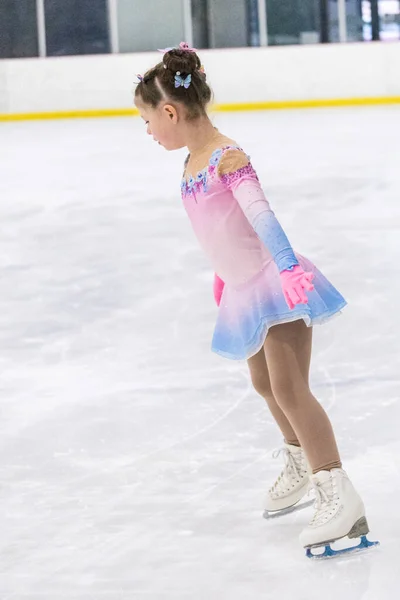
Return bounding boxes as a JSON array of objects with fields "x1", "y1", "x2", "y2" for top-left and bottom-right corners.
[{"x1": 135, "y1": 45, "x2": 212, "y2": 120}]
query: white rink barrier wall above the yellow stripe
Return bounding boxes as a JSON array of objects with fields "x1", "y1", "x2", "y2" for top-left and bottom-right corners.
[{"x1": 0, "y1": 43, "x2": 400, "y2": 114}]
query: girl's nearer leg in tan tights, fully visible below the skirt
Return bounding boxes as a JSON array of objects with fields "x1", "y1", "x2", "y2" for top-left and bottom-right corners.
[{"x1": 264, "y1": 320, "x2": 342, "y2": 473}]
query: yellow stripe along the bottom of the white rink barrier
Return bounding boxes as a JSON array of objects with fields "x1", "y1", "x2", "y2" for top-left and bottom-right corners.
[{"x1": 0, "y1": 96, "x2": 400, "y2": 121}]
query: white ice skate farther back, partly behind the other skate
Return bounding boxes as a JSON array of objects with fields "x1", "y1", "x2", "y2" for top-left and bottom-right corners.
[{"x1": 264, "y1": 444, "x2": 313, "y2": 519}]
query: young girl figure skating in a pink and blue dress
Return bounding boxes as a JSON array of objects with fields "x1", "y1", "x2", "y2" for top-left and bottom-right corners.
[{"x1": 135, "y1": 42, "x2": 368, "y2": 547}]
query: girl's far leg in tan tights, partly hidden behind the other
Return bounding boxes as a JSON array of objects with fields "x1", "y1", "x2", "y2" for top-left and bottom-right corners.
[{"x1": 247, "y1": 348, "x2": 300, "y2": 446}]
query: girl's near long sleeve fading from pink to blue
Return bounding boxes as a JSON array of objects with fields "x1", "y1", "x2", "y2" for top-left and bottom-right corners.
[{"x1": 219, "y1": 150, "x2": 299, "y2": 272}]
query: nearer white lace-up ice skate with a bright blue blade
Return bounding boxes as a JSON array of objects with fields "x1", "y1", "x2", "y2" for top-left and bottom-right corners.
[{"x1": 300, "y1": 469, "x2": 378, "y2": 558}]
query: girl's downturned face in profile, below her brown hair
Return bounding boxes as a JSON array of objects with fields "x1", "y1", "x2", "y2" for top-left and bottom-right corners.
[{"x1": 135, "y1": 99, "x2": 186, "y2": 150}]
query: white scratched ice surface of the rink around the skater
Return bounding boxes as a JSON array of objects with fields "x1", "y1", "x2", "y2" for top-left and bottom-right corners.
[{"x1": 0, "y1": 107, "x2": 400, "y2": 600}]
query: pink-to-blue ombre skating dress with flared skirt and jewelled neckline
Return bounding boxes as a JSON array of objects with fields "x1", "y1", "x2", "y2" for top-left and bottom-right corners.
[{"x1": 181, "y1": 146, "x2": 346, "y2": 360}]
